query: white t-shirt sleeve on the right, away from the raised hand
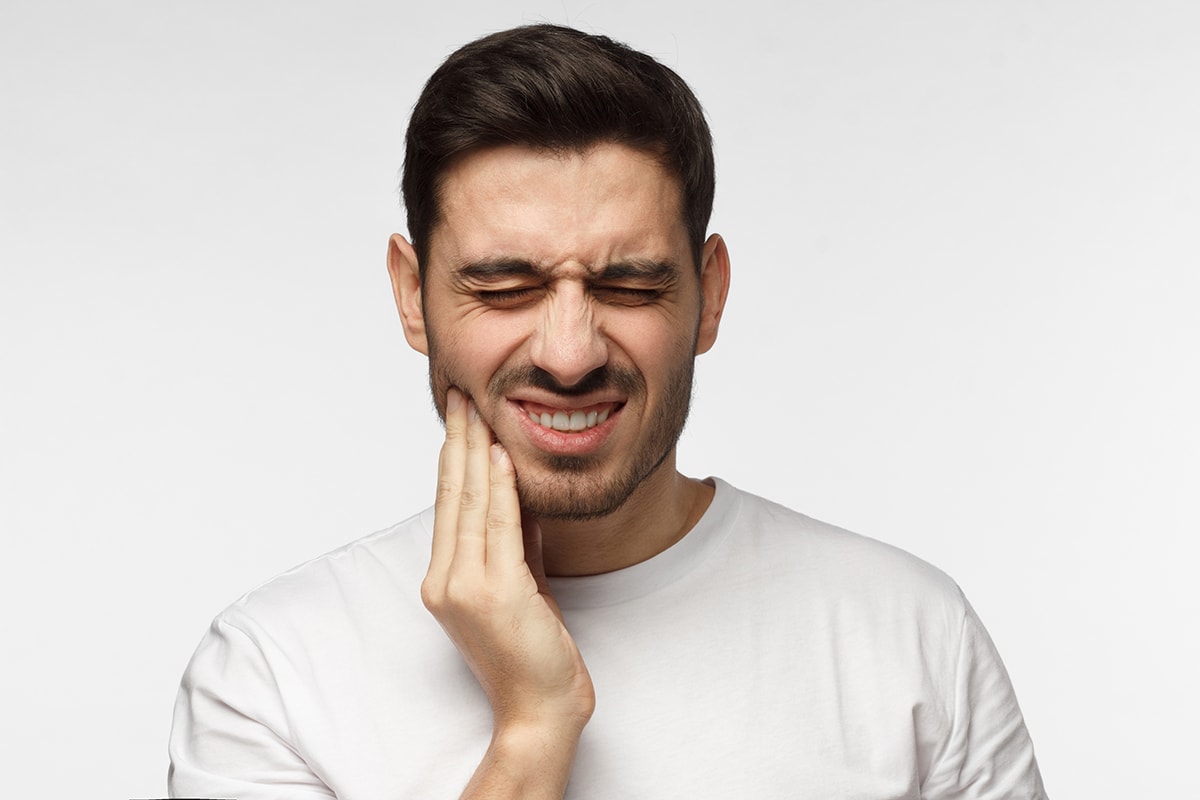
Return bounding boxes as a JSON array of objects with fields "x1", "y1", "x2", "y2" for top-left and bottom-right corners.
[{"x1": 922, "y1": 600, "x2": 1046, "y2": 800}]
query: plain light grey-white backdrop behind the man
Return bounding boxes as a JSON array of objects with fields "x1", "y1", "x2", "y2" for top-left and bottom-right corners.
[{"x1": 0, "y1": 0, "x2": 1200, "y2": 799}]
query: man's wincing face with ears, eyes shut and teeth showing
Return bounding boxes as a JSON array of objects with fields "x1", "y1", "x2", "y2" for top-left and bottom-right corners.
[{"x1": 391, "y1": 144, "x2": 727, "y2": 519}]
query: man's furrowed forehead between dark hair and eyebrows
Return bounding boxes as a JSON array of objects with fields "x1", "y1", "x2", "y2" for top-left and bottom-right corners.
[{"x1": 430, "y1": 143, "x2": 689, "y2": 275}]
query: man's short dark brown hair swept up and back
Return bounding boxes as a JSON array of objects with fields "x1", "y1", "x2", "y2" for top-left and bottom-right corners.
[{"x1": 401, "y1": 25, "x2": 715, "y2": 279}]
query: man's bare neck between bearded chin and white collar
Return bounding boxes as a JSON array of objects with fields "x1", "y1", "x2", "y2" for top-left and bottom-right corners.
[{"x1": 538, "y1": 453, "x2": 713, "y2": 576}]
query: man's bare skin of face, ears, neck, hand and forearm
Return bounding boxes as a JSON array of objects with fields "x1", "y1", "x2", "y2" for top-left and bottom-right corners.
[{"x1": 389, "y1": 144, "x2": 728, "y2": 798}]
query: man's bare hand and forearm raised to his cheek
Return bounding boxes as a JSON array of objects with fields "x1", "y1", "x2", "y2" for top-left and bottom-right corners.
[{"x1": 421, "y1": 389, "x2": 595, "y2": 798}]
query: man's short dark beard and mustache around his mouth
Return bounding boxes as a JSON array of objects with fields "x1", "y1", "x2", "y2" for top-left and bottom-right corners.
[{"x1": 430, "y1": 338, "x2": 695, "y2": 522}]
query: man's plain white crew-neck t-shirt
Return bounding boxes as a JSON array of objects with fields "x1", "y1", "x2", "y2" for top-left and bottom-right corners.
[{"x1": 169, "y1": 480, "x2": 1045, "y2": 800}]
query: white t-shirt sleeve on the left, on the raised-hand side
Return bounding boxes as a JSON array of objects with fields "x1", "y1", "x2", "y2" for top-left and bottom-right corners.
[{"x1": 167, "y1": 616, "x2": 335, "y2": 800}]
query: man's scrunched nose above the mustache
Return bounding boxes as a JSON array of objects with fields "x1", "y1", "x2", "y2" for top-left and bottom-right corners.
[{"x1": 529, "y1": 281, "x2": 608, "y2": 386}]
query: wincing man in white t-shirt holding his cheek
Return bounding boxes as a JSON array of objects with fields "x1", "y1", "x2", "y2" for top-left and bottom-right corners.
[{"x1": 170, "y1": 25, "x2": 1044, "y2": 800}]
